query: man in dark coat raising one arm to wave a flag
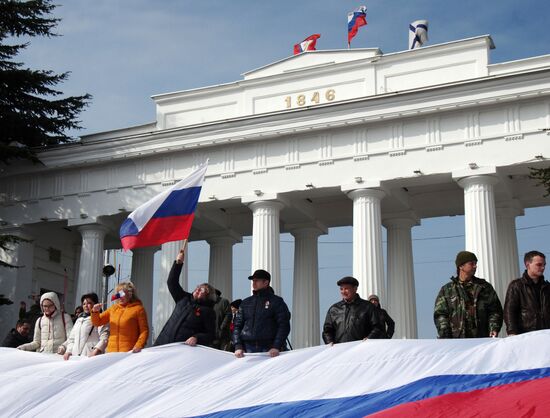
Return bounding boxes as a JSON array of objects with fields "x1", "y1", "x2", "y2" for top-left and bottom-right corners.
[{"x1": 154, "y1": 249, "x2": 216, "y2": 346}]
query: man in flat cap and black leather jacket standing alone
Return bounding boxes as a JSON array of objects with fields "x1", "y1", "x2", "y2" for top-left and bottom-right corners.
[{"x1": 323, "y1": 276, "x2": 383, "y2": 345}]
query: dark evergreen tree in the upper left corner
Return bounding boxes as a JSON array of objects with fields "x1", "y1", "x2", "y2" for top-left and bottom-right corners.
[{"x1": 0, "y1": 0, "x2": 91, "y2": 164}]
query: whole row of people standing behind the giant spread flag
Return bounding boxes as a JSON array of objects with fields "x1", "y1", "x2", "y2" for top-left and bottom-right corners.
[{"x1": 3, "y1": 249, "x2": 550, "y2": 360}]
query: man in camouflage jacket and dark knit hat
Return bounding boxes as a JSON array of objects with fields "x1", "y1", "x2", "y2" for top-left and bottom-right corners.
[{"x1": 434, "y1": 251, "x2": 502, "y2": 338}]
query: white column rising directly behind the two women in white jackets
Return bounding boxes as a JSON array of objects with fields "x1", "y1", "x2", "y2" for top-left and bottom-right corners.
[{"x1": 75, "y1": 224, "x2": 107, "y2": 305}]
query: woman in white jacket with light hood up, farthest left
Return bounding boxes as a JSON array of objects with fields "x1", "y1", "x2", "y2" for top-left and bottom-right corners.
[{"x1": 17, "y1": 292, "x2": 73, "y2": 354}]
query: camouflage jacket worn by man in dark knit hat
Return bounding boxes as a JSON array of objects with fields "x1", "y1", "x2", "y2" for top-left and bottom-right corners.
[{"x1": 434, "y1": 277, "x2": 502, "y2": 338}]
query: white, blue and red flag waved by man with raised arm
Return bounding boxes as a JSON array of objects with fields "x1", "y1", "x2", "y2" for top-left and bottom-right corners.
[{"x1": 120, "y1": 163, "x2": 208, "y2": 250}]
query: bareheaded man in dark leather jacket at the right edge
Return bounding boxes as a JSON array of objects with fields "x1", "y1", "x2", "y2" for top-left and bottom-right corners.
[{"x1": 504, "y1": 251, "x2": 550, "y2": 335}]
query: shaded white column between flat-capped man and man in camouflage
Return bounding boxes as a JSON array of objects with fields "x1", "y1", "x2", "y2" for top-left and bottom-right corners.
[{"x1": 384, "y1": 218, "x2": 419, "y2": 338}]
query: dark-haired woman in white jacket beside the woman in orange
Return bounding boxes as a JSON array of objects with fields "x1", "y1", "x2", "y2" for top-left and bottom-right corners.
[{"x1": 57, "y1": 293, "x2": 109, "y2": 360}]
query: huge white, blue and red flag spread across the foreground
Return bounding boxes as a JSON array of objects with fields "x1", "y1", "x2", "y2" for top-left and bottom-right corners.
[{"x1": 0, "y1": 330, "x2": 550, "y2": 418}]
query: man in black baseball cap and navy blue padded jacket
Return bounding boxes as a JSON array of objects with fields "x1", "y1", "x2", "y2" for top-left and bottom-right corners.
[{"x1": 233, "y1": 270, "x2": 290, "y2": 358}]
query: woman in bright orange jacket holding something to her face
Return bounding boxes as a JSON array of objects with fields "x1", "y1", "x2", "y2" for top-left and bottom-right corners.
[{"x1": 92, "y1": 282, "x2": 149, "y2": 353}]
